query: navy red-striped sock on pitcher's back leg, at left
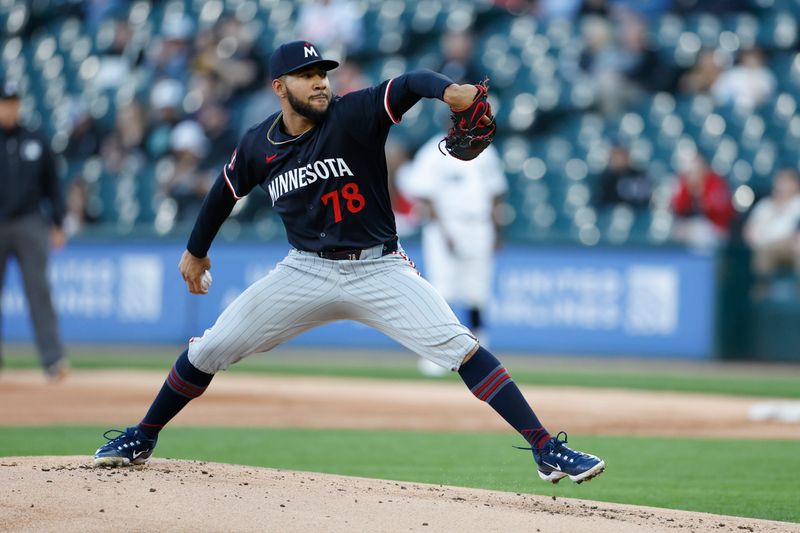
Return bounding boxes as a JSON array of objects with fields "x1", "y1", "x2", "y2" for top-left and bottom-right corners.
[{"x1": 138, "y1": 350, "x2": 214, "y2": 439}]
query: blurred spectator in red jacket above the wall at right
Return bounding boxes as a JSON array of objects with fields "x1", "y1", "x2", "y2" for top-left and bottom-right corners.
[{"x1": 672, "y1": 154, "x2": 734, "y2": 249}]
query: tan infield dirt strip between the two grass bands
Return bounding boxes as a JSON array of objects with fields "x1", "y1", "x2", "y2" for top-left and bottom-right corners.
[{"x1": 0, "y1": 370, "x2": 800, "y2": 439}]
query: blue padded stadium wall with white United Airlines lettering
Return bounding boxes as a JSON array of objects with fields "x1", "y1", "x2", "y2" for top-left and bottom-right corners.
[{"x1": 3, "y1": 242, "x2": 715, "y2": 359}]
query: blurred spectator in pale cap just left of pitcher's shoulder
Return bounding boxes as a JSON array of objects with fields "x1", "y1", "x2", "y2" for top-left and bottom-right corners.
[{"x1": 164, "y1": 120, "x2": 212, "y2": 221}]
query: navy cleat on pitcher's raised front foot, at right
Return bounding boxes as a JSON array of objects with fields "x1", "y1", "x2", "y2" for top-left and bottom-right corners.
[{"x1": 533, "y1": 431, "x2": 606, "y2": 483}]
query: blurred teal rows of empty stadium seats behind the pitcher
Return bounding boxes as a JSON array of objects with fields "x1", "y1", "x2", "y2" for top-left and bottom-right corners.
[{"x1": 0, "y1": 0, "x2": 800, "y2": 244}]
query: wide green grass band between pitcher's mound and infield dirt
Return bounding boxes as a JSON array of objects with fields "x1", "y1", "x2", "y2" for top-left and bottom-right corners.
[{"x1": 0, "y1": 427, "x2": 800, "y2": 522}]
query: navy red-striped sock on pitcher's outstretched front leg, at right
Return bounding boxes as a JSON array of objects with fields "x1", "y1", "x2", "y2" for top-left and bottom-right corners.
[{"x1": 458, "y1": 347, "x2": 550, "y2": 448}]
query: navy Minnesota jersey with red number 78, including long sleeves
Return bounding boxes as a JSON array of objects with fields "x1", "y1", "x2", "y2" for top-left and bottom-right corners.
[{"x1": 187, "y1": 71, "x2": 452, "y2": 257}]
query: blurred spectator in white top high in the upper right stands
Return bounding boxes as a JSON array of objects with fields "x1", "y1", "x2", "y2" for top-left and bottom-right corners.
[{"x1": 711, "y1": 48, "x2": 777, "y2": 109}]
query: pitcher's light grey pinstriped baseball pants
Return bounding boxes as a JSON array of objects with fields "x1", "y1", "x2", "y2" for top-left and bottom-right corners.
[{"x1": 189, "y1": 246, "x2": 477, "y2": 374}]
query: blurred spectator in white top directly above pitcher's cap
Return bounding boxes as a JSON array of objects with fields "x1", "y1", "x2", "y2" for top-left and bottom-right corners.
[{"x1": 295, "y1": 0, "x2": 364, "y2": 57}]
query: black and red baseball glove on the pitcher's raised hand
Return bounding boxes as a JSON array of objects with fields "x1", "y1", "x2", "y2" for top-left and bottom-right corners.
[{"x1": 439, "y1": 79, "x2": 497, "y2": 161}]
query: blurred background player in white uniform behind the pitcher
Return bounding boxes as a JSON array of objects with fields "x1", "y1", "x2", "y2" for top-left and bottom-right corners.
[{"x1": 398, "y1": 135, "x2": 508, "y2": 376}]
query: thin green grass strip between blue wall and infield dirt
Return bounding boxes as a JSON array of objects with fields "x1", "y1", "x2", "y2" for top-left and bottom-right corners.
[{"x1": 1, "y1": 347, "x2": 800, "y2": 398}]
